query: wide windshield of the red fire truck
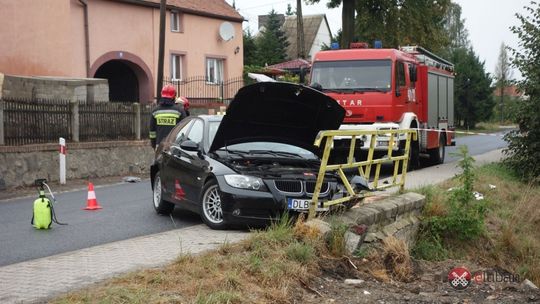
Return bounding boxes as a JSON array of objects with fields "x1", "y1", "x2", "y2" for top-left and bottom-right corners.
[{"x1": 311, "y1": 60, "x2": 392, "y2": 92}]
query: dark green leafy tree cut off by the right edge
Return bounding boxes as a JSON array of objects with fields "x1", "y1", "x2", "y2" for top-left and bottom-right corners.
[{"x1": 505, "y1": 2, "x2": 540, "y2": 183}]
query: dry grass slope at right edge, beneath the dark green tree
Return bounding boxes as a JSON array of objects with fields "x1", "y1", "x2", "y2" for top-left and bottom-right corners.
[{"x1": 468, "y1": 165, "x2": 540, "y2": 285}]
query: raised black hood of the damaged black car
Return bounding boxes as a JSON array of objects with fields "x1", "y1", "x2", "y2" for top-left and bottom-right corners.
[{"x1": 210, "y1": 82, "x2": 345, "y2": 152}]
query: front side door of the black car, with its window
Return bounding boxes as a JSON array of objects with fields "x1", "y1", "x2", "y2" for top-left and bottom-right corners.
[{"x1": 168, "y1": 118, "x2": 209, "y2": 204}]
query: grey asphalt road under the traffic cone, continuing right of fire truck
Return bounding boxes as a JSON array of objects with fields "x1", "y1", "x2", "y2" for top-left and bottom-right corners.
[{"x1": 0, "y1": 131, "x2": 506, "y2": 266}]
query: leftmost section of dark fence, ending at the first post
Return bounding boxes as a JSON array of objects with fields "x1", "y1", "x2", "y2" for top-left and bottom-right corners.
[{"x1": 0, "y1": 99, "x2": 72, "y2": 145}]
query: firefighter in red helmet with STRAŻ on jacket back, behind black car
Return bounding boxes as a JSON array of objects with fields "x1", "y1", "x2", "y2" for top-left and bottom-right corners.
[{"x1": 149, "y1": 85, "x2": 187, "y2": 149}]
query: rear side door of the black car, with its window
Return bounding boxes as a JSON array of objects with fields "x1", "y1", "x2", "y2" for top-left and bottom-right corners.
[{"x1": 161, "y1": 119, "x2": 193, "y2": 203}]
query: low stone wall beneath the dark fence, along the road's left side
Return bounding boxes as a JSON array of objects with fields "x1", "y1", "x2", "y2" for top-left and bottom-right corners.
[{"x1": 0, "y1": 140, "x2": 154, "y2": 190}]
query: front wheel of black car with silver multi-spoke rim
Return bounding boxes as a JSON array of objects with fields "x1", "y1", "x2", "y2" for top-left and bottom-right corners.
[{"x1": 199, "y1": 179, "x2": 227, "y2": 230}]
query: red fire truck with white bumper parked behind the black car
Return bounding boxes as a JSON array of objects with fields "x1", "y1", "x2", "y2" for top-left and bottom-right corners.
[{"x1": 311, "y1": 46, "x2": 455, "y2": 167}]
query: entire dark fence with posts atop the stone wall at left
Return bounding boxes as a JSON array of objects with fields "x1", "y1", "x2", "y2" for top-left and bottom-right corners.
[{"x1": 0, "y1": 99, "x2": 154, "y2": 146}]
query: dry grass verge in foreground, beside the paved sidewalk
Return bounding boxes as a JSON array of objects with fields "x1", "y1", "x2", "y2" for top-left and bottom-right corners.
[{"x1": 53, "y1": 216, "x2": 330, "y2": 304}]
